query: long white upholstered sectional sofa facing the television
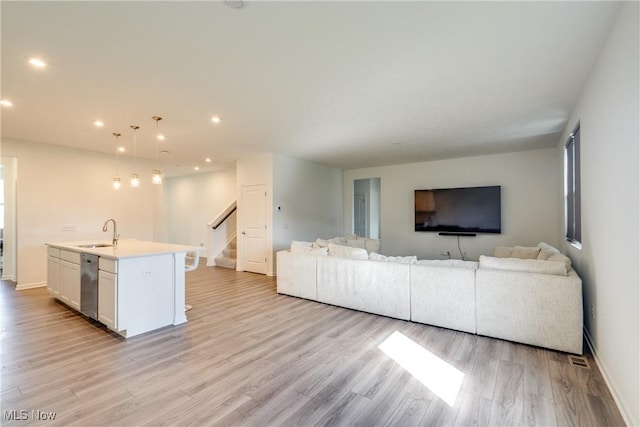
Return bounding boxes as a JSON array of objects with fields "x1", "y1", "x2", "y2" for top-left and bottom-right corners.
[{"x1": 277, "y1": 241, "x2": 583, "y2": 354}]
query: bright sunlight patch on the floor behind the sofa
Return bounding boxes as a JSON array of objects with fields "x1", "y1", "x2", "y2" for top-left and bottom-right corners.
[{"x1": 378, "y1": 331, "x2": 464, "y2": 407}]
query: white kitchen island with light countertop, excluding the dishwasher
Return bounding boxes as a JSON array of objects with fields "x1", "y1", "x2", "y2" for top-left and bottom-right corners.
[{"x1": 47, "y1": 239, "x2": 202, "y2": 338}]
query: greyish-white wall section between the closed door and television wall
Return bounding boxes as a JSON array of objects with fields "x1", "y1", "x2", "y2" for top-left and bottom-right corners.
[{"x1": 273, "y1": 155, "x2": 342, "y2": 252}]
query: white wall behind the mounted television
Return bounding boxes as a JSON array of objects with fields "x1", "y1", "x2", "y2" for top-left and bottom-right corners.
[{"x1": 343, "y1": 148, "x2": 560, "y2": 259}]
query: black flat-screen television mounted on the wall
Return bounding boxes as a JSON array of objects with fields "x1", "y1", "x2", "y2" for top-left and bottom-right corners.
[{"x1": 415, "y1": 185, "x2": 502, "y2": 234}]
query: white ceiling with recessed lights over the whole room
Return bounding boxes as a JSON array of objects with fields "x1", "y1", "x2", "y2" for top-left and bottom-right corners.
[{"x1": 0, "y1": 1, "x2": 619, "y2": 175}]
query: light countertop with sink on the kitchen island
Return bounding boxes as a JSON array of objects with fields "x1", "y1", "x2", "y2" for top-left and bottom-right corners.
[{"x1": 47, "y1": 239, "x2": 204, "y2": 260}]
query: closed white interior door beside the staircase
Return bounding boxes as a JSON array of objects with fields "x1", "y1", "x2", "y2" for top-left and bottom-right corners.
[{"x1": 240, "y1": 185, "x2": 267, "y2": 274}]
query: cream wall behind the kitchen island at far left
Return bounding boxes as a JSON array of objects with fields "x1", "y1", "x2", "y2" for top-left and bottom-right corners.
[{"x1": 2, "y1": 139, "x2": 161, "y2": 288}]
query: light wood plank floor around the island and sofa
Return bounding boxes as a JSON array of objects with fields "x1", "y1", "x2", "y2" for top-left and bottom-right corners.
[{"x1": 0, "y1": 266, "x2": 624, "y2": 426}]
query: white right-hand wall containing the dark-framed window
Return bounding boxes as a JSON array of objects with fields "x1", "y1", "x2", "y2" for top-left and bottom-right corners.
[{"x1": 558, "y1": 2, "x2": 640, "y2": 425}]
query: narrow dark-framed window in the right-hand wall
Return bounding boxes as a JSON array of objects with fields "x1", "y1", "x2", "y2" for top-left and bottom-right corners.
[{"x1": 564, "y1": 124, "x2": 582, "y2": 246}]
